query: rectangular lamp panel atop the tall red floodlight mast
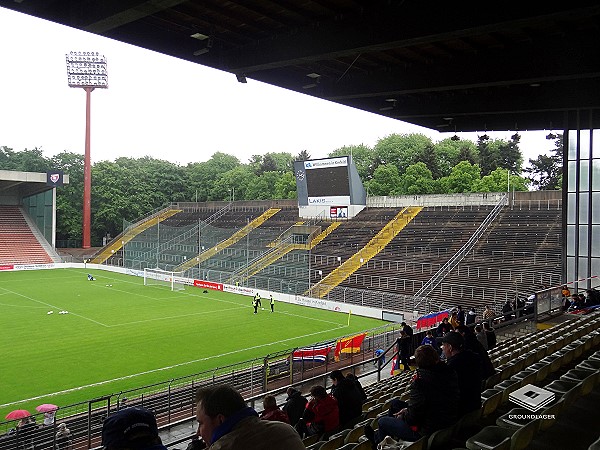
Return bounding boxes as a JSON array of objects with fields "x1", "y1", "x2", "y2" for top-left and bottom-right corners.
[{"x1": 66, "y1": 52, "x2": 108, "y2": 88}]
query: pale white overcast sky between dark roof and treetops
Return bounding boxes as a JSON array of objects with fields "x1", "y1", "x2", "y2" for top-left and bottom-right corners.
[{"x1": 0, "y1": 8, "x2": 552, "y2": 164}]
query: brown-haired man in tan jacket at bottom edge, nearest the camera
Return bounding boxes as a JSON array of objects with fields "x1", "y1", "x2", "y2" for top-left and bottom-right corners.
[{"x1": 195, "y1": 385, "x2": 305, "y2": 450}]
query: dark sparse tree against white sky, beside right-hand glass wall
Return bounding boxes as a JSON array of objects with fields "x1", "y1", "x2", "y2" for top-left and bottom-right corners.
[{"x1": 524, "y1": 133, "x2": 564, "y2": 191}]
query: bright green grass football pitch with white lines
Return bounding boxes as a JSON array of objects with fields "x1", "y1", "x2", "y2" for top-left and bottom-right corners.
[{"x1": 0, "y1": 269, "x2": 383, "y2": 420}]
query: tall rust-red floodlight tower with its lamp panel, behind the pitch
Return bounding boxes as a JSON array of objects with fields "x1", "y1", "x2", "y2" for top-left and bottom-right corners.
[{"x1": 66, "y1": 52, "x2": 108, "y2": 248}]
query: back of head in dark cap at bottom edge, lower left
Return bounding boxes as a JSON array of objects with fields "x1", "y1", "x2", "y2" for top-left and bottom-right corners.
[{"x1": 102, "y1": 407, "x2": 167, "y2": 450}]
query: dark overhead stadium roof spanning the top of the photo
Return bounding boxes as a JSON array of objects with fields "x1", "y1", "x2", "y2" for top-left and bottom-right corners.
[{"x1": 0, "y1": 0, "x2": 600, "y2": 132}]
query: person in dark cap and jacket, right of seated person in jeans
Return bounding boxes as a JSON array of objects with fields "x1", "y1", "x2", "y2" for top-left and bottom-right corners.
[{"x1": 442, "y1": 331, "x2": 483, "y2": 416}]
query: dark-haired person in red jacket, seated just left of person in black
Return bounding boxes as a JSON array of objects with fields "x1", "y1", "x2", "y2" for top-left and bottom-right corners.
[{"x1": 294, "y1": 386, "x2": 340, "y2": 438}]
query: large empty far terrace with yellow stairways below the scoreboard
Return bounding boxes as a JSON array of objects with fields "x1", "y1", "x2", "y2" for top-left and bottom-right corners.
[{"x1": 92, "y1": 192, "x2": 565, "y2": 315}]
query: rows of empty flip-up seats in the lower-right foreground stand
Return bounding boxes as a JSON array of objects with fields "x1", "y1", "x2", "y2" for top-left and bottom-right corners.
[{"x1": 304, "y1": 314, "x2": 600, "y2": 450}]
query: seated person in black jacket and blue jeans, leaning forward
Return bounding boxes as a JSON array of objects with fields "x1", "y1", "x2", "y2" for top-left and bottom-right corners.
[{"x1": 365, "y1": 345, "x2": 458, "y2": 444}]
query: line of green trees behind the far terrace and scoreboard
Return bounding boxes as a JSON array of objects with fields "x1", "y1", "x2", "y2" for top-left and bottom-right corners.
[{"x1": 0, "y1": 133, "x2": 563, "y2": 246}]
